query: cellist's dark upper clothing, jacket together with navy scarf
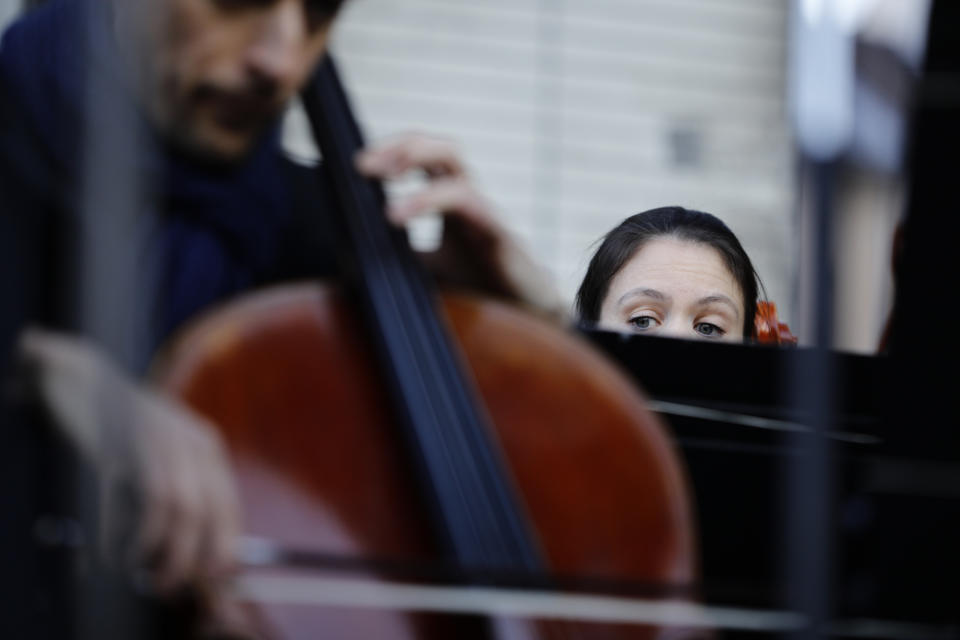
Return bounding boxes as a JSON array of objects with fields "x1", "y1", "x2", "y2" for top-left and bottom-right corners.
[{"x1": 0, "y1": 0, "x2": 335, "y2": 637}]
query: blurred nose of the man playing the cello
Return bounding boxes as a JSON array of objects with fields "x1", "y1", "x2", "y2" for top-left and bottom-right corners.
[{"x1": 247, "y1": 0, "x2": 307, "y2": 86}]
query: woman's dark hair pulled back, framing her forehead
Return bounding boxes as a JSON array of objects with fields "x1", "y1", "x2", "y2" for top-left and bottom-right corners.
[{"x1": 577, "y1": 207, "x2": 762, "y2": 338}]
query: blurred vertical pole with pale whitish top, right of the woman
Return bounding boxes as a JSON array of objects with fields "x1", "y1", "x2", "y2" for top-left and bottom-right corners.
[{"x1": 781, "y1": 0, "x2": 854, "y2": 638}]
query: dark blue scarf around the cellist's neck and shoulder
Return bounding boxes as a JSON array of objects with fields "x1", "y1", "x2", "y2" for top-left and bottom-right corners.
[{"x1": 0, "y1": 0, "x2": 290, "y2": 341}]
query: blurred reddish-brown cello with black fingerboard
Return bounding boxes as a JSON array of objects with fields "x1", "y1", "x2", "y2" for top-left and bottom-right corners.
[{"x1": 154, "y1": 56, "x2": 696, "y2": 638}]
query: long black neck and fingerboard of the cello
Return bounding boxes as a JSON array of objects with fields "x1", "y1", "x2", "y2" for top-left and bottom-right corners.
[{"x1": 302, "y1": 55, "x2": 540, "y2": 572}]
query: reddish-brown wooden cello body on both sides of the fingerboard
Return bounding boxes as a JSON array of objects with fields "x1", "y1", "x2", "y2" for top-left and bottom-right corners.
[{"x1": 156, "y1": 284, "x2": 695, "y2": 637}]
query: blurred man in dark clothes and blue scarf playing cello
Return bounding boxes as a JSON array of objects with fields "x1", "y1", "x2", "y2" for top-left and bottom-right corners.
[{"x1": 0, "y1": 0, "x2": 564, "y2": 632}]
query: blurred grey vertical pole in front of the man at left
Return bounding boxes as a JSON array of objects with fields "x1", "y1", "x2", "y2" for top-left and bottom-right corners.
[{"x1": 72, "y1": 2, "x2": 152, "y2": 640}]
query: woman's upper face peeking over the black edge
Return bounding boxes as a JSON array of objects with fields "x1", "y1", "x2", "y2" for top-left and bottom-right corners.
[{"x1": 599, "y1": 236, "x2": 746, "y2": 342}]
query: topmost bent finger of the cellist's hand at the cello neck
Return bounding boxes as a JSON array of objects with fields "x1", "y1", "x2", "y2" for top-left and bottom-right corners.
[{"x1": 356, "y1": 134, "x2": 466, "y2": 179}]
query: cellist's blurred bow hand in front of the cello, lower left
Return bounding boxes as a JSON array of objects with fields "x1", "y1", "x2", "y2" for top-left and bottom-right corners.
[{"x1": 19, "y1": 329, "x2": 246, "y2": 590}]
